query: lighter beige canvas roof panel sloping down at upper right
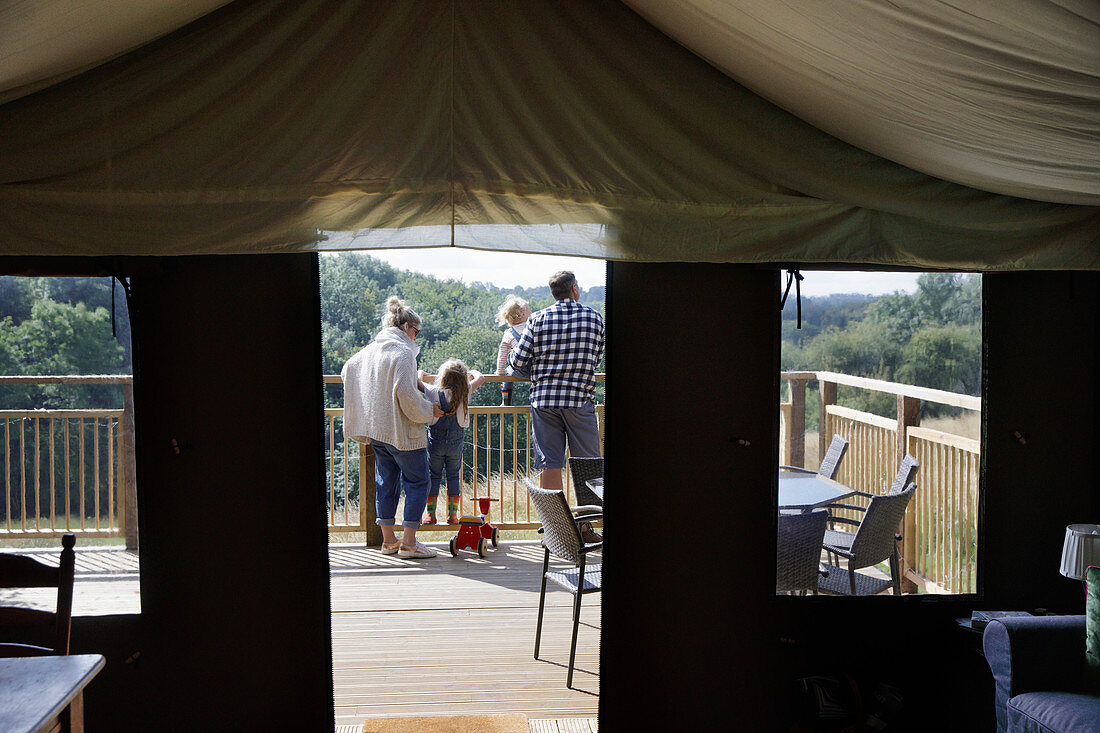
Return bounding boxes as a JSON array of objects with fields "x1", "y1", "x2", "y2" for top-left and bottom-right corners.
[{"x1": 626, "y1": 0, "x2": 1100, "y2": 206}]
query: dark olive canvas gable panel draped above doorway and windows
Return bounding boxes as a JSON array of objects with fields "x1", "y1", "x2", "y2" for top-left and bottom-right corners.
[{"x1": 0, "y1": 0, "x2": 1100, "y2": 269}]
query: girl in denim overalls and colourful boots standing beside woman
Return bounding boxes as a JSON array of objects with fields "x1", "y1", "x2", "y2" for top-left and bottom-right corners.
[{"x1": 421, "y1": 359, "x2": 485, "y2": 524}]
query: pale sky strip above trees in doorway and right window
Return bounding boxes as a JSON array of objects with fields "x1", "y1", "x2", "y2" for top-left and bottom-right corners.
[{"x1": 354, "y1": 248, "x2": 919, "y2": 295}]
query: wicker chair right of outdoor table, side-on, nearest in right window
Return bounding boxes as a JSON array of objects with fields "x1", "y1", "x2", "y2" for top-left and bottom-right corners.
[{"x1": 818, "y1": 483, "x2": 916, "y2": 595}]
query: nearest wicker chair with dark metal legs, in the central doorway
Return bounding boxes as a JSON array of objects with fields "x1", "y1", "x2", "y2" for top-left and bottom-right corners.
[{"x1": 524, "y1": 477, "x2": 603, "y2": 688}]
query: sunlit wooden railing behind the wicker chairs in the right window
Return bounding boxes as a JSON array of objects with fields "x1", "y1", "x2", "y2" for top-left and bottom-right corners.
[{"x1": 780, "y1": 372, "x2": 981, "y2": 593}]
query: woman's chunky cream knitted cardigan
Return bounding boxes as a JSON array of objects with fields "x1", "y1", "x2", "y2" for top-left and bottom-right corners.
[{"x1": 340, "y1": 326, "x2": 432, "y2": 450}]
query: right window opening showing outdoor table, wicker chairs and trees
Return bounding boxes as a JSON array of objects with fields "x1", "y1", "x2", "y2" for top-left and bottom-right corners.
[{"x1": 777, "y1": 272, "x2": 982, "y2": 594}]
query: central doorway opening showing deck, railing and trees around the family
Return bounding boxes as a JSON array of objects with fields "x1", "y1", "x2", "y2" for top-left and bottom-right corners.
[{"x1": 320, "y1": 248, "x2": 606, "y2": 730}]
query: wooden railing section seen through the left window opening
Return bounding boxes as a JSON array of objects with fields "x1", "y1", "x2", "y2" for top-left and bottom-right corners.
[{"x1": 0, "y1": 375, "x2": 138, "y2": 547}]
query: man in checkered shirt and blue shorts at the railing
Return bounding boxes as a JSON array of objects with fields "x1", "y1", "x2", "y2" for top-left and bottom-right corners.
[{"x1": 508, "y1": 271, "x2": 605, "y2": 489}]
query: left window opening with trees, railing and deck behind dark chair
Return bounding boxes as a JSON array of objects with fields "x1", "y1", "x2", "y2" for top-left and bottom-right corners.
[{"x1": 0, "y1": 276, "x2": 141, "y2": 616}]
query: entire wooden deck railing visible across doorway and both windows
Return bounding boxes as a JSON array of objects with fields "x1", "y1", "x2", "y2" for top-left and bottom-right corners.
[{"x1": 0, "y1": 372, "x2": 981, "y2": 592}]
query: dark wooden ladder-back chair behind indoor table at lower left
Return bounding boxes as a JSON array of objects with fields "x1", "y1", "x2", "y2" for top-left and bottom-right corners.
[{"x1": 0, "y1": 534, "x2": 76, "y2": 657}]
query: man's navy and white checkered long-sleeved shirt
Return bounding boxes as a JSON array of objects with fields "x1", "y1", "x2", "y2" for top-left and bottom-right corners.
[{"x1": 508, "y1": 298, "x2": 605, "y2": 408}]
